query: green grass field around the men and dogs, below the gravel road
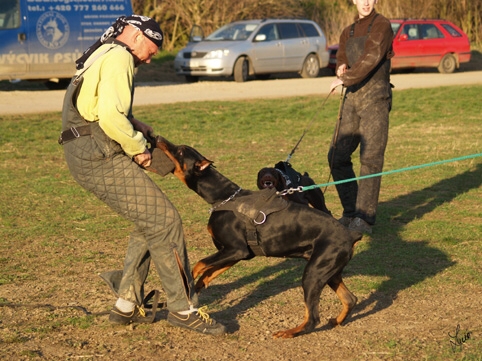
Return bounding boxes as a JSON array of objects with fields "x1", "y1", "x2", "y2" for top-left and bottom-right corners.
[{"x1": 0, "y1": 86, "x2": 482, "y2": 360}]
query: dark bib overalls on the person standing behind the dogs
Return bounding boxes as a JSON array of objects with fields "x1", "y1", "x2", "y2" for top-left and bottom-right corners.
[{"x1": 328, "y1": 16, "x2": 392, "y2": 225}]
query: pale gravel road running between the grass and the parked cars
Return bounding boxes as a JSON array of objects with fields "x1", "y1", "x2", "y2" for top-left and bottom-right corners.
[{"x1": 0, "y1": 71, "x2": 482, "y2": 115}]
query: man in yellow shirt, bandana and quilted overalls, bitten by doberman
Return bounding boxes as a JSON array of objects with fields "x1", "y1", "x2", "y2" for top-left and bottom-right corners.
[{"x1": 59, "y1": 15, "x2": 226, "y2": 335}]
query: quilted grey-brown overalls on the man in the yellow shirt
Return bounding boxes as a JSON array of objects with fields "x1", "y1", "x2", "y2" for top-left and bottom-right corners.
[{"x1": 62, "y1": 54, "x2": 197, "y2": 312}]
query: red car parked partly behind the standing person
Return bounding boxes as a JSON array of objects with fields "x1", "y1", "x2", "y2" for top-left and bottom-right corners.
[{"x1": 328, "y1": 19, "x2": 470, "y2": 73}]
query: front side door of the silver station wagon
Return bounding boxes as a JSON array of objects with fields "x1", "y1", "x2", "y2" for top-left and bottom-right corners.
[{"x1": 251, "y1": 23, "x2": 284, "y2": 74}]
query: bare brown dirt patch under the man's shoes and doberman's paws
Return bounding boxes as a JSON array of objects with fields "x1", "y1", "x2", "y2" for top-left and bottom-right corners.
[{"x1": 0, "y1": 234, "x2": 482, "y2": 361}]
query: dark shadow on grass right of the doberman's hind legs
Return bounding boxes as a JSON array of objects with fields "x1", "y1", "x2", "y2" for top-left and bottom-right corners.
[{"x1": 346, "y1": 164, "x2": 482, "y2": 322}]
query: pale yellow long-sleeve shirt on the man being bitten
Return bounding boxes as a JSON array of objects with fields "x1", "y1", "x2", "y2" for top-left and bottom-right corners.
[{"x1": 77, "y1": 44, "x2": 147, "y2": 157}]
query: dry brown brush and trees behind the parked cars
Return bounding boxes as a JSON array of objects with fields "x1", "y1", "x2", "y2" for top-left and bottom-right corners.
[{"x1": 132, "y1": 0, "x2": 482, "y2": 50}]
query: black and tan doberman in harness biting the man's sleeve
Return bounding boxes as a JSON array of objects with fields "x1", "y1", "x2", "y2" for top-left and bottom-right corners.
[{"x1": 157, "y1": 137, "x2": 362, "y2": 338}]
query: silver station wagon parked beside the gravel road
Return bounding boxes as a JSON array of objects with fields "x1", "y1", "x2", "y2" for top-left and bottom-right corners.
[{"x1": 174, "y1": 19, "x2": 329, "y2": 82}]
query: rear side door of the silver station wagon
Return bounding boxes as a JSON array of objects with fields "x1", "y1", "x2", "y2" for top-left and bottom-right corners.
[{"x1": 278, "y1": 22, "x2": 310, "y2": 71}]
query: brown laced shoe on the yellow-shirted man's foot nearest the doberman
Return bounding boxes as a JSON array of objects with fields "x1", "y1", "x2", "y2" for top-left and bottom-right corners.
[{"x1": 167, "y1": 306, "x2": 226, "y2": 336}]
